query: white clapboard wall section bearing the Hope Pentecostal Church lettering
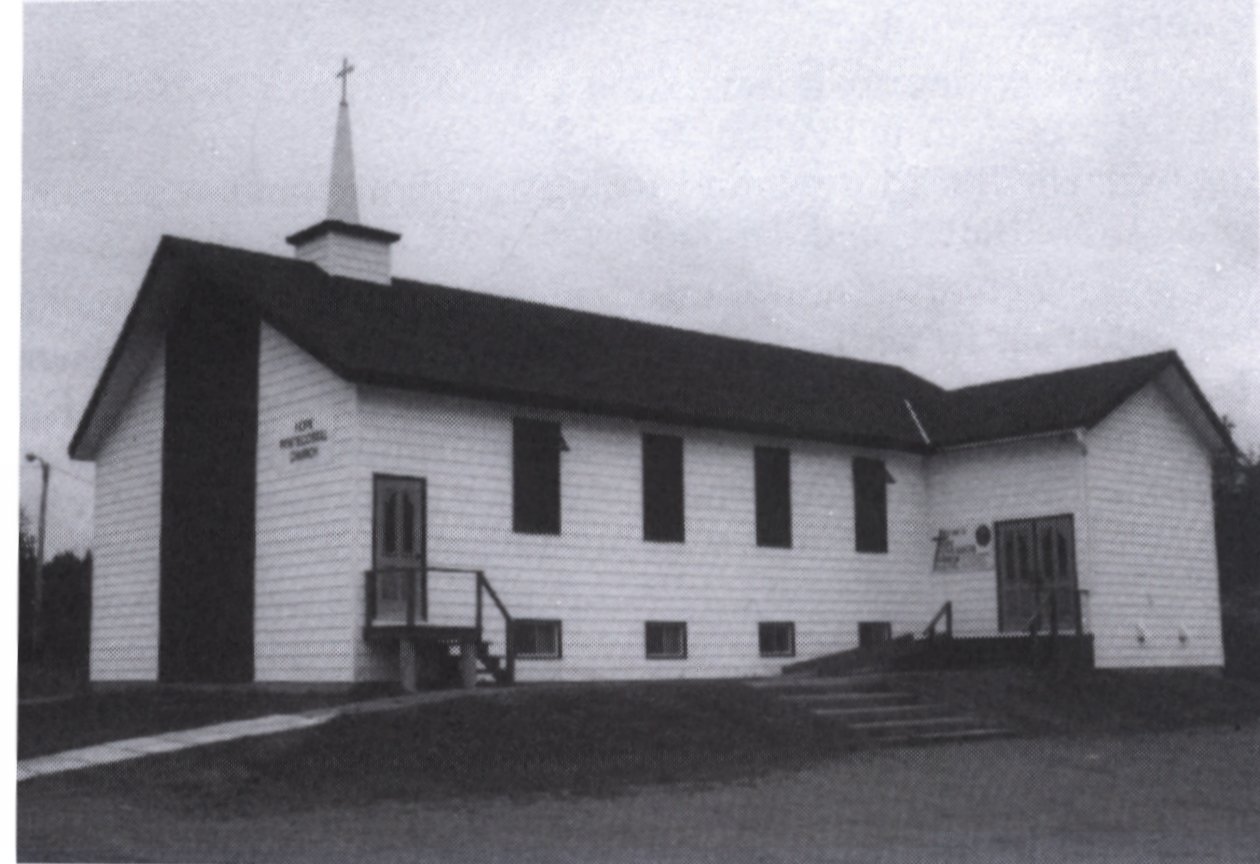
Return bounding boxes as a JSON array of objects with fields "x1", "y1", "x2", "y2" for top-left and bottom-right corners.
[{"x1": 255, "y1": 324, "x2": 364, "y2": 681}]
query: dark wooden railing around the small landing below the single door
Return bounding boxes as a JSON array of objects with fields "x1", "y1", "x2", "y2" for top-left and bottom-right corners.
[{"x1": 364, "y1": 567, "x2": 517, "y2": 681}]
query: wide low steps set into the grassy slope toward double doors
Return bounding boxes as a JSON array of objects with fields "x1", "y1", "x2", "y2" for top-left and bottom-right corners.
[{"x1": 750, "y1": 674, "x2": 1013, "y2": 746}]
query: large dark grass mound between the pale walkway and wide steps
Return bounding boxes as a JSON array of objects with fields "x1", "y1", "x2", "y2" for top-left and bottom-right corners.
[{"x1": 33, "y1": 681, "x2": 853, "y2": 816}]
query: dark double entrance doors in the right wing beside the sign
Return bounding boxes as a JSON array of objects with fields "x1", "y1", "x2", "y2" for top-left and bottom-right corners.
[{"x1": 995, "y1": 516, "x2": 1076, "y2": 632}]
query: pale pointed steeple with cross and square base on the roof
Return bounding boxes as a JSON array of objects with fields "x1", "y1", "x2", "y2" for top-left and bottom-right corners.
[{"x1": 285, "y1": 58, "x2": 401, "y2": 285}]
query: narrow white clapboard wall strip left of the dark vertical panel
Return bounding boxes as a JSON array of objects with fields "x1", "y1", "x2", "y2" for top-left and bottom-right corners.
[{"x1": 91, "y1": 343, "x2": 166, "y2": 681}]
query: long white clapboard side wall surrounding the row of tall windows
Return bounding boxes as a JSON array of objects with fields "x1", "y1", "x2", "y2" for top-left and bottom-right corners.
[{"x1": 355, "y1": 388, "x2": 934, "y2": 681}]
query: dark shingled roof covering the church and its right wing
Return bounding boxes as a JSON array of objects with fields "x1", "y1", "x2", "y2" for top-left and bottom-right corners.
[{"x1": 71, "y1": 237, "x2": 1227, "y2": 452}]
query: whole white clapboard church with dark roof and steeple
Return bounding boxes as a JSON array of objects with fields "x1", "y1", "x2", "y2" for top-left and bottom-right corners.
[{"x1": 69, "y1": 66, "x2": 1234, "y2": 686}]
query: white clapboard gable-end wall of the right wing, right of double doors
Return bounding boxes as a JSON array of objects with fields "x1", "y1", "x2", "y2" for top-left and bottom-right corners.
[{"x1": 1087, "y1": 383, "x2": 1223, "y2": 666}]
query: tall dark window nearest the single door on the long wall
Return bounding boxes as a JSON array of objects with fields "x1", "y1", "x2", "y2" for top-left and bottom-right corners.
[{"x1": 512, "y1": 417, "x2": 563, "y2": 534}]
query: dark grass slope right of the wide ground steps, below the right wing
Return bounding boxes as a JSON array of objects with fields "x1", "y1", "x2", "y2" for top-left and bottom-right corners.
[{"x1": 897, "y1": 669, "x2": 1260, "y2": 734}]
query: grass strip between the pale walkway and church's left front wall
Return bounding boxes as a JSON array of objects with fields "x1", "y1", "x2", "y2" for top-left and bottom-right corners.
[{"x1": 18, "y1": 688, "x2": 393, "y2": 759}]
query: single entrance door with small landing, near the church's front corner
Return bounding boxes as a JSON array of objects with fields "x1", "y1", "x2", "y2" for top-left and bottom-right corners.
[{"x1": 372, "y1": 475, "x2": 427, "y2": 623}]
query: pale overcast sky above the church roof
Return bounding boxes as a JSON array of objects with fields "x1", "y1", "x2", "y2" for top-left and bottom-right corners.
[{"x1": 20, "y1": 0, "x2": 1260, "y2": 552}]
